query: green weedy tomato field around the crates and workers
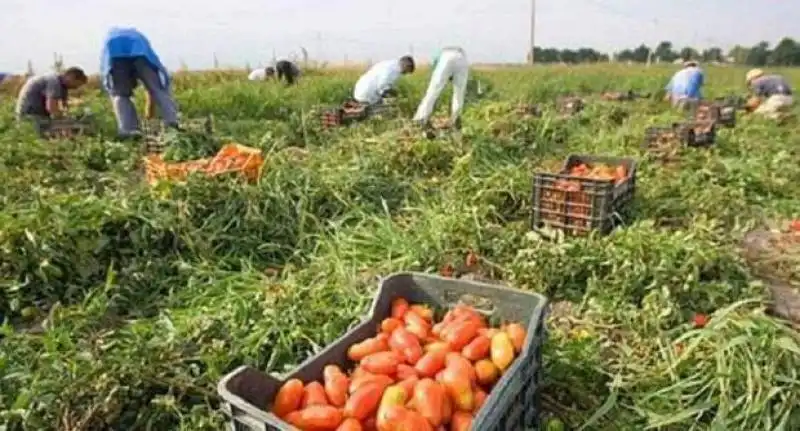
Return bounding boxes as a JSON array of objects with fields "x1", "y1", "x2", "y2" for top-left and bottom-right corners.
[{"x1": 0, "y1": 65, "x2": 800, "y2": 431}]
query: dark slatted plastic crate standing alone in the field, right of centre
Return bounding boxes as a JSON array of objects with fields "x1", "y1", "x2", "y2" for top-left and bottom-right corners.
[{"x1": 532, "y1": 155, "x2": 636, "y2": 235}]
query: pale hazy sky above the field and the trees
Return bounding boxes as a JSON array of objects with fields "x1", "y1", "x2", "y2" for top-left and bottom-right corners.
[{"x1": 0, "y1": 0, "x2": 800, "y2": 73}]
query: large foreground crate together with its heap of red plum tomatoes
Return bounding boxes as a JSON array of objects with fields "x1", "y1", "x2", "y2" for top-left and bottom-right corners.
[{"x1": 218, "y1": 273, "x2": 547, "y2": 431}]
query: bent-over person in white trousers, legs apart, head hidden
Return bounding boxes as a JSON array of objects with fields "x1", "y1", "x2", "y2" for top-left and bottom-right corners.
[{"x1": 414, "y1": 47, "x2": 469, "y2": 125}]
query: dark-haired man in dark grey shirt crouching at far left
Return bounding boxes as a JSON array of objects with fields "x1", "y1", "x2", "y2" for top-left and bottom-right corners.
[{"x1": 16, "y1": 67, "x2": 87, "y2": 131}]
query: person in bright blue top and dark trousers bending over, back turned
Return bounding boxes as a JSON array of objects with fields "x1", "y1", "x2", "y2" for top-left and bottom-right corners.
[{"x1": 100, "y1": 27, "x2": 178, "y2": 137}]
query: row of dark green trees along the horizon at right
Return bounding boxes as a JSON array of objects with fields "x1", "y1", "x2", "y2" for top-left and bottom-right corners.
[{"x1": 533, "y1": 37, "x2": 800, "y2": 66}]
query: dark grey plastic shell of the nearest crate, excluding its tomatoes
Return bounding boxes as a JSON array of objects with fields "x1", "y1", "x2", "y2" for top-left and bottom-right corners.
[{"x1": 217, "y1": 273, "x2": 547, "y2": 431}]
